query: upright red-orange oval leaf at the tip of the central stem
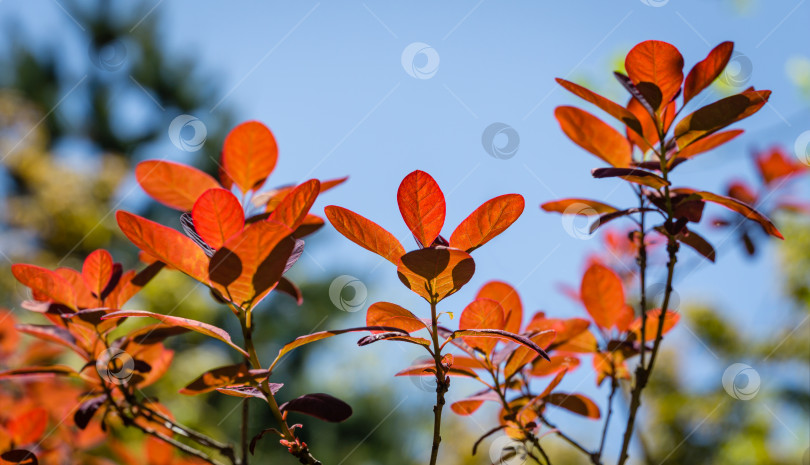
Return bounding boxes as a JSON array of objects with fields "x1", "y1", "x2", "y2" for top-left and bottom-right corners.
[{"x1": 397, "y1": 170, "x2": 447, "y2": 247}]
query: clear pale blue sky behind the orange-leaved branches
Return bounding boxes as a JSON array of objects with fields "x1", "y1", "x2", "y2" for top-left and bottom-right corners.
[{"x1": 0, "y1": 0, "x2": 810, "y2": 456}]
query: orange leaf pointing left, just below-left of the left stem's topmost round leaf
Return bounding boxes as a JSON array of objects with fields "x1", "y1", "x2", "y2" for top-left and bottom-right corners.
[{"x1": 135, "y1": 160, "x2": 219, "y2": 211}]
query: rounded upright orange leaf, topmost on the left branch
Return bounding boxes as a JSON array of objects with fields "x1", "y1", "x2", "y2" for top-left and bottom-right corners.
[{"x1": 222, "y1": 121, "x2": 278, "y2": 193}]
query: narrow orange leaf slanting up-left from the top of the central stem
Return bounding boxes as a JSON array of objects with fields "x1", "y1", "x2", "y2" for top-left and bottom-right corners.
[{"x1": 325, "y1": 205, "x2": 405, "y2": 265}]
